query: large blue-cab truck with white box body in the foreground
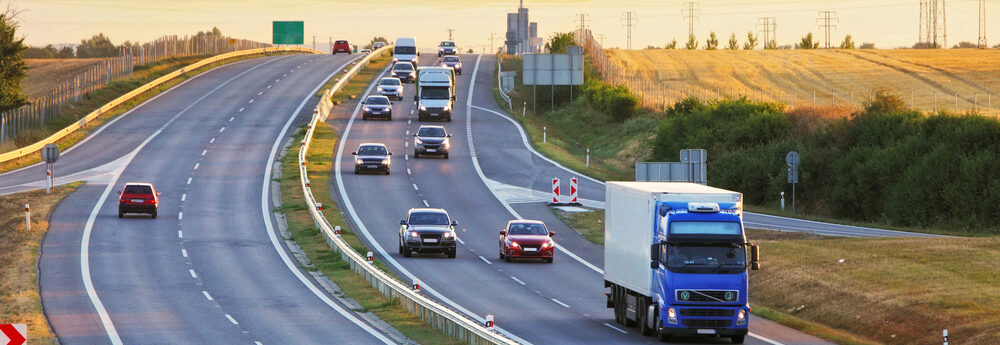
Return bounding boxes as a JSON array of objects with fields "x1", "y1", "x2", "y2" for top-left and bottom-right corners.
[{"x1": 604, "y1": 182, "x2": 760, "y2": 344}]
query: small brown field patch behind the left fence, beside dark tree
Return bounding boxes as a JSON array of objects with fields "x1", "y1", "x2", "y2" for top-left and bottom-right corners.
[{"x1": 21, "y1": 58, "x2": 108, "y2": 99}]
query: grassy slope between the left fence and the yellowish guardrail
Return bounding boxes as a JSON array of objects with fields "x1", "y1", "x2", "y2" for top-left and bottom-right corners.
[{"x1": 0, "y1": 53, "x2": 306, "y2": 172}]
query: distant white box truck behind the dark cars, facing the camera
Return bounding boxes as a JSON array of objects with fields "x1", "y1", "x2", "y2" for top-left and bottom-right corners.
[{"x1": 413, "y1": 67, "x2": 457, "y2": 122}]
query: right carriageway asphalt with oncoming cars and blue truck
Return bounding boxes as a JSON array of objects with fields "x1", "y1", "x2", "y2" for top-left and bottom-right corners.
[{"x1": 330, "y1": 55, "x2": 840, "y2": 344}]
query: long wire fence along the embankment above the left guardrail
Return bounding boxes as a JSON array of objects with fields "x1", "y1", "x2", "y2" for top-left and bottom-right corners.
[{"x1": 0, "y1": 35, "x2": 271, "y2": 143}]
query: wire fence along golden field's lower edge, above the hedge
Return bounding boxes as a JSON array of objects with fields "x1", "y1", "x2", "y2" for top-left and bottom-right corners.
[{"x1": 574, "y1": 29, "x2": 1000, "y2": 115}]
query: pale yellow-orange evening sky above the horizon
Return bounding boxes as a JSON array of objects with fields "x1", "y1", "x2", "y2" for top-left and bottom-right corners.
[{"x1": 7, "y1": 0, "x2": 1000, "y2": 51}]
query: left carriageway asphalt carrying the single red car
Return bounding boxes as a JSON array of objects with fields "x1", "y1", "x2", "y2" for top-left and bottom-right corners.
[{"x1": 27, "y1": 55, "x2": 388, "y2": 344}]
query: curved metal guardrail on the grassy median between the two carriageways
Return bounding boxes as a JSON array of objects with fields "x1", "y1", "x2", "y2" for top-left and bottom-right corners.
[{"x1": 298, "y1": 45, "x2": 517, "y2": 345}]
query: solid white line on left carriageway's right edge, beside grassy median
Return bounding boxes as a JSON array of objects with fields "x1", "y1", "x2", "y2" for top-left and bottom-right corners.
[{"x1": 260, "y1": 57, "x2": 394, "y2": 344}]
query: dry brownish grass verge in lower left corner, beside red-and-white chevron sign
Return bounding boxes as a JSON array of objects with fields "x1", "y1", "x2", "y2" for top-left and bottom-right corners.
[{"x1": 0, "y1": 182, "x2": 83, "y2": 344}]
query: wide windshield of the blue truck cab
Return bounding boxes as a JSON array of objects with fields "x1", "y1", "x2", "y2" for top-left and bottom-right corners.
[{"x1": 666, "y1": 243, "x2": 746, "y2": 268}]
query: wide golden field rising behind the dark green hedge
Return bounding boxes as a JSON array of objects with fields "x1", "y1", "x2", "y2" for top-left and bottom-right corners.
[{"x1": 604, "y1": 49, "x2": 1000, "y2": 114}]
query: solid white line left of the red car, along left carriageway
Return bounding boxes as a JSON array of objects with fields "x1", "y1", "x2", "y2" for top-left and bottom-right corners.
[{"x1": 80, "y1": 58, "x2": 280, "y2": 345}]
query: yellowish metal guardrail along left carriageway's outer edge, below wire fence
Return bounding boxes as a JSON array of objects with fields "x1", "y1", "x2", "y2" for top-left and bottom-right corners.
[{"x1": 0, "y1": 47, "x2": 323, "y2": 163}]
